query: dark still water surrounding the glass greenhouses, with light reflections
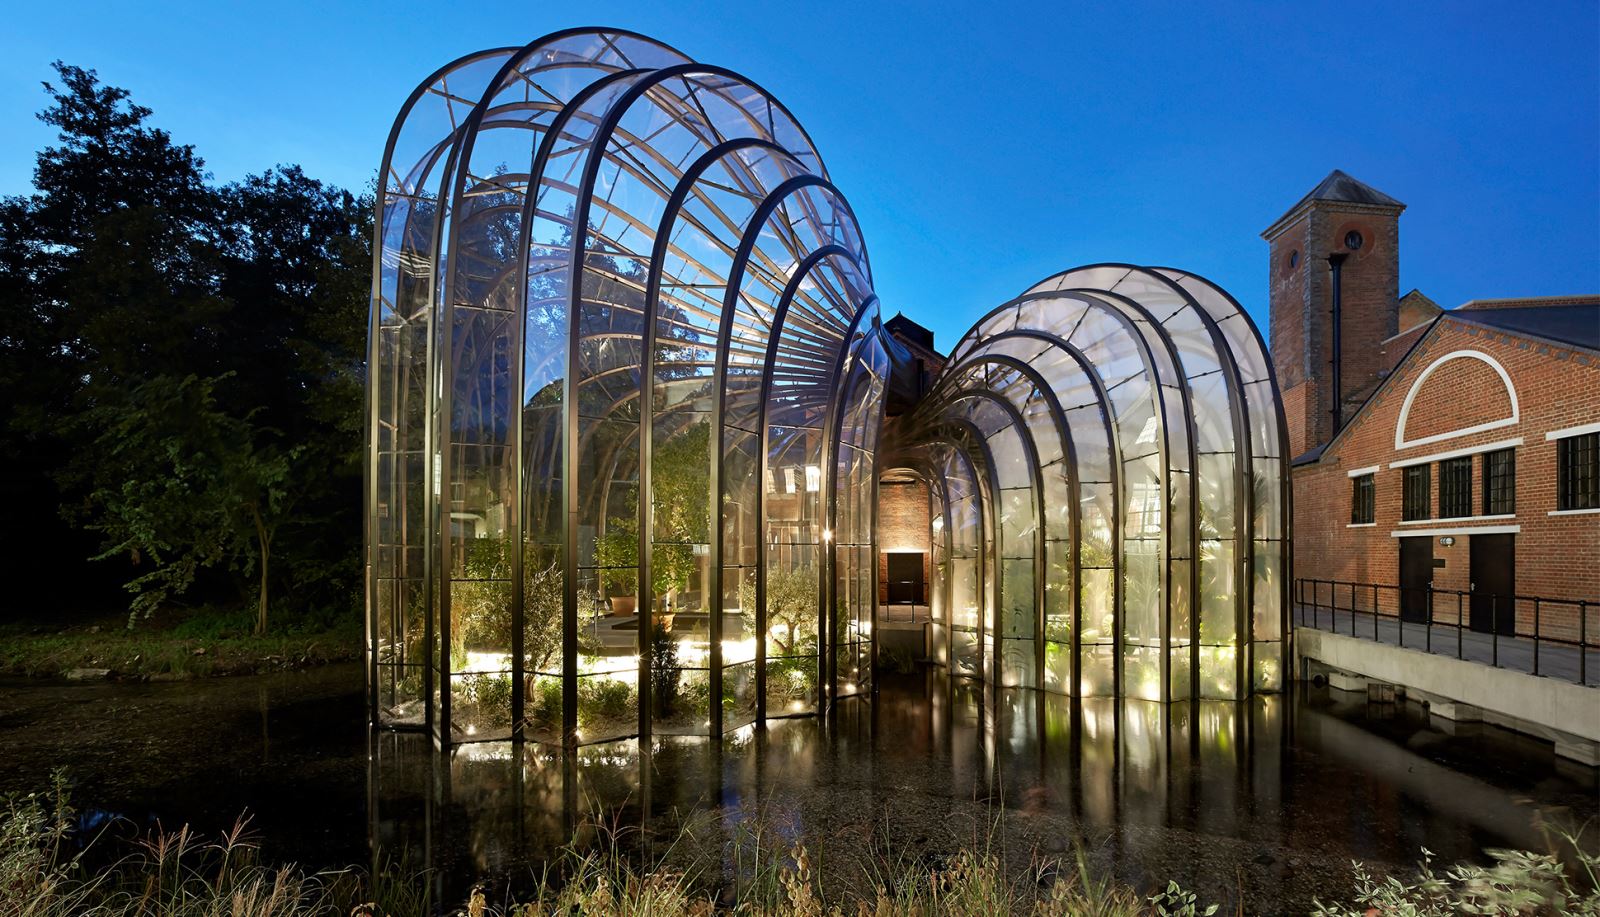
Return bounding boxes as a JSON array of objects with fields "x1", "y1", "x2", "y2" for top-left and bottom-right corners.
[{"x1": 0, "y1": 666, "x2": 1600, "y2": 912}]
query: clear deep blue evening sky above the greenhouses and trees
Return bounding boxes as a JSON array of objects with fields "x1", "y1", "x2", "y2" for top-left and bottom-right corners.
[{"x1": 0, "y1": 0, "x2": 1600, "y2": 347}]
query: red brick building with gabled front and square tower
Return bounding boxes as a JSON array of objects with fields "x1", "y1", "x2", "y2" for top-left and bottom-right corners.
[{"x1": 1262, "y1": 171, "x2": 1600, "y2": 640}]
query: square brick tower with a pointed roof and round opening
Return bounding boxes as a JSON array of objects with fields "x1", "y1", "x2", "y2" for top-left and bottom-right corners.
[{"x1": 1261, "y1": 170, "x2": 1405, "y2": 458}]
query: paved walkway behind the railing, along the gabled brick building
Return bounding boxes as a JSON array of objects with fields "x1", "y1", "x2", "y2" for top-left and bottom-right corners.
[{"x1": 1294, "y1": 605, "x2": 1600, "y2": 687}]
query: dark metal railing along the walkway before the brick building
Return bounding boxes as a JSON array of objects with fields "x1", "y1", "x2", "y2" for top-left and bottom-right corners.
[{"x1": 1294, "y1": 579, "x2": 1600, "y2": 685}]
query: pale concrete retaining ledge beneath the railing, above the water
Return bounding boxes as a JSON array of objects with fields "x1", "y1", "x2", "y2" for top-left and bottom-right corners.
[{"x1": 1294, "y1": 627, "x2": 1600, "y2": 745}]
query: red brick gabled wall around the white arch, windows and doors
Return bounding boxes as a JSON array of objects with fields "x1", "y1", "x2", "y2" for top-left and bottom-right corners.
[{"x1": 1293, "y1": 317, "x2": 1600, "y2": 637}]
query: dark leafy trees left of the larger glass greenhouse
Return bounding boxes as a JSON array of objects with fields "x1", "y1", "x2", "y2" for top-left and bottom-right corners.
[{"x1": 0, "y1": 62, "x2": 371, "y2": 631}]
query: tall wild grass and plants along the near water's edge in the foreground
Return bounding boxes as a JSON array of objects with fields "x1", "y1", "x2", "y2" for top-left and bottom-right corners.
[{"x1": 0, "y1": 775, "x2": 1600, "y2": 917}]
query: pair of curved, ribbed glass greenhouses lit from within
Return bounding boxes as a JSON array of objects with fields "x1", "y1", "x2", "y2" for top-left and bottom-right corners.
[{"x1": 366, "y1": 30, "x2": 1285, "y2": 744}]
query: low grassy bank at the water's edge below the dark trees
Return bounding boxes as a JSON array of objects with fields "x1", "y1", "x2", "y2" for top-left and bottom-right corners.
[{"x1": 0, "y1": 611, "x2": 362, "y2": 682}]
